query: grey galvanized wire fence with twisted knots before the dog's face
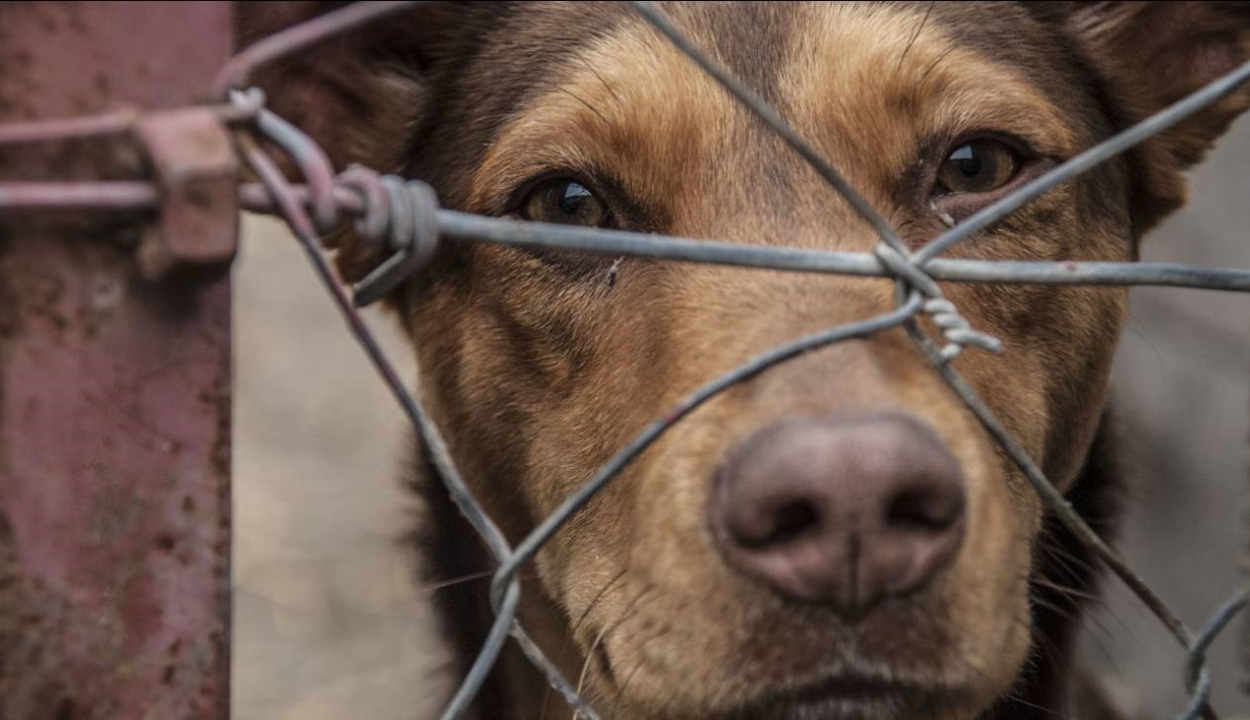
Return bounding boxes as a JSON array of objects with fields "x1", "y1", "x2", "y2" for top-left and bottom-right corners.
[{"x1": 0, "y1": 1, "x2": 1250, "y2": 720}]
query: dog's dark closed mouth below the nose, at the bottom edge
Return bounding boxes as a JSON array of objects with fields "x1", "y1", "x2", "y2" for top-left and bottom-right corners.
[{"x1": 725, "y1": 671, "x2": 958, "y2": 720}]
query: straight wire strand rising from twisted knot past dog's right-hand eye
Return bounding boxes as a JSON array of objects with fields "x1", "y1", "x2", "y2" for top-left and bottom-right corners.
[{"x1": 915, "y1": 56, "x2": 1250, "y2": 265}]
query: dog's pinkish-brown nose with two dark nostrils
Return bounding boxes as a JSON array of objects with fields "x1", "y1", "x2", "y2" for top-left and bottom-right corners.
[{"x1": 711, "y1": 414, "x2": 965, "y2": 620}]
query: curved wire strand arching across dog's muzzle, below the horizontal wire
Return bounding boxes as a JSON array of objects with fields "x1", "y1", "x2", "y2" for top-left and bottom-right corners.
[{"x1": 491, "y1": 293, "x2": 924, "y2": 603}]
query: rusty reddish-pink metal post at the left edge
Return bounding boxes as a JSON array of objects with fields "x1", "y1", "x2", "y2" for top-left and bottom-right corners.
[{"x1": 0, "y1": 3, "x2": 238, "y2": 720}]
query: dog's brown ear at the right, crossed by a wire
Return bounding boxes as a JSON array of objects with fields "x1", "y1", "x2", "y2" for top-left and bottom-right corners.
[{"x1": 1064, "y1": 1, "x2": 1250, "y2": 234}]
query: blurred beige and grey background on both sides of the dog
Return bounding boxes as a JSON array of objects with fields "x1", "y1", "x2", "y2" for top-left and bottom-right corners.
[{"x1": 233, "y1": 116, "x2": 1250, "y2": 720}]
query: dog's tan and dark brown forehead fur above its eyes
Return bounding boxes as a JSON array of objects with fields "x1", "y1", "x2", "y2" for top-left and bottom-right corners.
[{"x1": 457, "y1": 3, "x2": 1098, "y2": 223}]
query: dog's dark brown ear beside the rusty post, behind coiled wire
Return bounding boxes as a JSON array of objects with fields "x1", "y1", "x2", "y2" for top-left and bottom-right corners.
[{"x1": 235, "y1": 1, "x2": 497, "y2": 283}]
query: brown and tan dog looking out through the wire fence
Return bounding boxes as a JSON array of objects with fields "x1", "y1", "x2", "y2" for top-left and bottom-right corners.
[{"x1": 239, "y1": 3, "x2": 1250, "y2": 720}]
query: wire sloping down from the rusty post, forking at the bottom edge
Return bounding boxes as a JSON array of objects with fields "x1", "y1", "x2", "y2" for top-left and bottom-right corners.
[{"x1": 236, "y1": 96, "x2": 599, "y2": 720}]
